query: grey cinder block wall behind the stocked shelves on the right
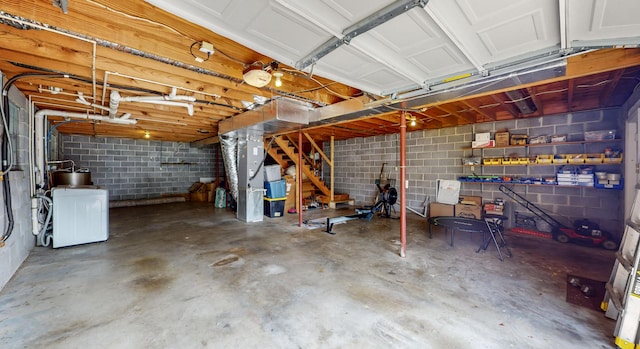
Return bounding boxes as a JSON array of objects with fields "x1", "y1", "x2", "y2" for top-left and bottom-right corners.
[{"x1": 324, "y1": 109, "x2": 624, "y2": 236}]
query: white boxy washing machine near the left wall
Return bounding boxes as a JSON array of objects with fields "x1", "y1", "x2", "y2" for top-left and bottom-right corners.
[{"x1": 51, "y1": 186, "x2": 109, "y2": 248}]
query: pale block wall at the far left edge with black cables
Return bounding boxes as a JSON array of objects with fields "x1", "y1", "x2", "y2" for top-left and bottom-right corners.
[{"x1": 0, "y1": 81, "x2": 35, "y2": 290}]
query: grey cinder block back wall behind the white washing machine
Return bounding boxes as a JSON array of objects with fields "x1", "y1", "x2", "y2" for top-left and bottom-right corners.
[{"x1": 62, "y1": 135, "x2": 224, "y2": 200}]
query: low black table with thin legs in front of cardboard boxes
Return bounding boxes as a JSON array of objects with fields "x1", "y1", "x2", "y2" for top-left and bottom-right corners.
[{"x1": 429, "y1": 215, "x2": 513, "y2": 261}]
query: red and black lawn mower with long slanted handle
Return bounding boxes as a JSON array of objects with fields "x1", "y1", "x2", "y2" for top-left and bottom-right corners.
[{"x1": 499, "y1": 185, "x2": 618, "y2": 250}]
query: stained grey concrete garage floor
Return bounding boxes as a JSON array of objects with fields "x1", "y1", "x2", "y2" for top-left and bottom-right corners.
[{"x1": 0, "y1": 203, "x2": 615, "y2": 349}]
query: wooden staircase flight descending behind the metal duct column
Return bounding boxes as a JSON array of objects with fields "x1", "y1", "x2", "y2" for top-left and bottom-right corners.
[{"x1": 265, "y1": 136, "x2": 331, "y2": 197}]
